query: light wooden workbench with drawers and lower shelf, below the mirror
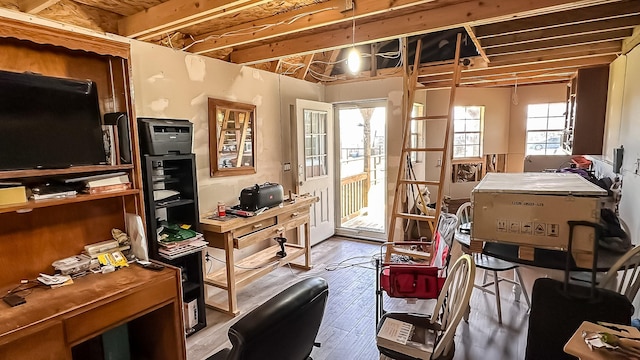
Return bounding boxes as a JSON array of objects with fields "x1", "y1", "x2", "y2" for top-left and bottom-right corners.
[{"x1": 200, "y1": 196, "x2": 318, "y2": 316}]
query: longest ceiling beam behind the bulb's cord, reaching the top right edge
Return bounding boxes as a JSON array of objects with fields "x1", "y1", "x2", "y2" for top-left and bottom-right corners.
[{"x1": 231, "y1": 0, "x2": 606, "y2": 64}]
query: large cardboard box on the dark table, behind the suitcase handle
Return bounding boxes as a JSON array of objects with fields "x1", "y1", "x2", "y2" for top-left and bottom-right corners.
[{"x1": 471, "y1": 173, "x2": 607, "y2": 267}]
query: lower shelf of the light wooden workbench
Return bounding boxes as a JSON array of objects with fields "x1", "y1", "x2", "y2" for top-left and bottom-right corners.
[{"x1": 204, "y1": 244, "x2": 305, "y2": 290}]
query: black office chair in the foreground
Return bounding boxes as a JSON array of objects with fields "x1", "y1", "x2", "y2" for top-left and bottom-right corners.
[{"x1": 207, "y1": 277, "x2": 329, "y2": 360}]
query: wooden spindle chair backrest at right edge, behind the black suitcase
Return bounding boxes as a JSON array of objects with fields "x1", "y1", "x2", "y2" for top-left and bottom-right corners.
[{"x1": 598, "y1": 246, "x2": 640, "y2": 302}]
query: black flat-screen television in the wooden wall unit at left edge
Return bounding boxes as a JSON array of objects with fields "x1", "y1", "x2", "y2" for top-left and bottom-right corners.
[{"x1": 0, "y1": 71, "x2": 106, "y2": 170}]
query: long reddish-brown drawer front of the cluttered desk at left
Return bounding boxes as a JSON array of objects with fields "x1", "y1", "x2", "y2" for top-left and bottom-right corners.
[{"x1": 64, "y1": 277, "x2": 178, "y2": 344}]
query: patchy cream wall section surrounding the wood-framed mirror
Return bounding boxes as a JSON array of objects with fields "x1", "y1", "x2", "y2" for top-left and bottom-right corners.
[{"x1": 131, "y1": 41, "x2": 324, "y2": 214}]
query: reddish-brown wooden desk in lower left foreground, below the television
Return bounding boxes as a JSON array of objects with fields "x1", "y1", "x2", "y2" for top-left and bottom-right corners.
[{"x1": 0, "y1": 265, "x2": 186, "y2": 360}]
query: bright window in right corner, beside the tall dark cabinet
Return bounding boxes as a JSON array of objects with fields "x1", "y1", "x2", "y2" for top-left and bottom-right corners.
[{"x1": 526, "y1": 103, "x2": 567, "y2": 155}]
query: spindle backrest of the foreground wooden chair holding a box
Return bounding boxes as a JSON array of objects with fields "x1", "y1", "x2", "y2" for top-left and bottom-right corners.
[{"x1": 431, "y1": 255, "x2": 476, "y2": 359}]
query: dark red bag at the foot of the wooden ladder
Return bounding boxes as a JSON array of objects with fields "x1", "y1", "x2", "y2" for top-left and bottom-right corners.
[{"x1": 380, "y1": 264, "x2": 445, "y2": 299}]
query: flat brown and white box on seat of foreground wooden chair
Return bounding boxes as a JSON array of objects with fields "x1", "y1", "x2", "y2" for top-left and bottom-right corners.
[{"x1": 376, "y1": 318, "x2": 436, "y2": 359}]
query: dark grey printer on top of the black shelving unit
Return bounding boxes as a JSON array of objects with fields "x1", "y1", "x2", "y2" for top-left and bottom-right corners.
[{"x1": 138, "y1": 118, "x2": 193, "y2": 155}]
